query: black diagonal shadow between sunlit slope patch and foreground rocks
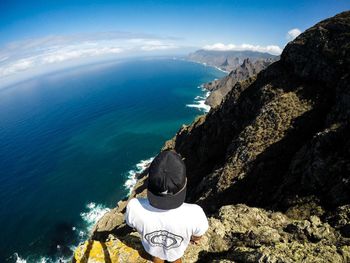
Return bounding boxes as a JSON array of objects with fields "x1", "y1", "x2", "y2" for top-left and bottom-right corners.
[{"x1": 200, "y1": 105, "x2": 325, "y2": 212}]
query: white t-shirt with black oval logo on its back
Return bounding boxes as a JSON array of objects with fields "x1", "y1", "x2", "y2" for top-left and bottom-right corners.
[{"x1": 125, "y1": 198, "x2": 208, "y2": 261}]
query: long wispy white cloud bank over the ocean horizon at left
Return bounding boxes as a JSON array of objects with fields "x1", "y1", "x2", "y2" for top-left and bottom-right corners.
[{"x1": 0, "y1": 32, "x2": 177, "y2": 79}]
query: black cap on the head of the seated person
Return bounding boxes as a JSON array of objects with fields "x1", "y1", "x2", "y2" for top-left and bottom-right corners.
[{"x1": 147, "y1": 150, "x2": 187, "y2": 210}]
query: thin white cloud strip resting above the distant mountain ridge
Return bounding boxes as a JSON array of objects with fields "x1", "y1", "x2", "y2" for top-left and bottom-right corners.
[{"x1": 203, "y1": 43, "x2": 282, "y2": 55}]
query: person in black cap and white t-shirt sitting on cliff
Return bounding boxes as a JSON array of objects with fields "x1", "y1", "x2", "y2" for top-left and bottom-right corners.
[{"x1": 125, "y1": 151, "x2": 208, "y2": 263}]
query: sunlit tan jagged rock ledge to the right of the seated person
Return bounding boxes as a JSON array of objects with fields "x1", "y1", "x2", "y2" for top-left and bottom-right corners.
[{"x1": 198, "y1": 204, "x2": 349, "y2": 263}]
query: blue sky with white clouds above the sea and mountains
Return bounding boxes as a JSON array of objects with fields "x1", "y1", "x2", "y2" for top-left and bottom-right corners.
[{"x1": 0, "y1": 0, "x2": 350, "y2": 87}]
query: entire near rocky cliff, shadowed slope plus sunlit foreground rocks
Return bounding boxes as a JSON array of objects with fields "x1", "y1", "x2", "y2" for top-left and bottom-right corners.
[{"x1": 74, "y1": 12, "x2": 350, "y2": 263}]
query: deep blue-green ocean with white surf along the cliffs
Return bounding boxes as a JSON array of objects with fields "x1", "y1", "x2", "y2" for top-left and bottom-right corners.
[{"x1": 0, "y1": 59, "x2": 224, "y2": 262}]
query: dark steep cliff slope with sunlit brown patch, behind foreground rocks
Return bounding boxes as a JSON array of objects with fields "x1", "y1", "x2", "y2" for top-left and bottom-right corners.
[{"x1": 164, "y1": 12, "x2": 350, "y2": 214}]
